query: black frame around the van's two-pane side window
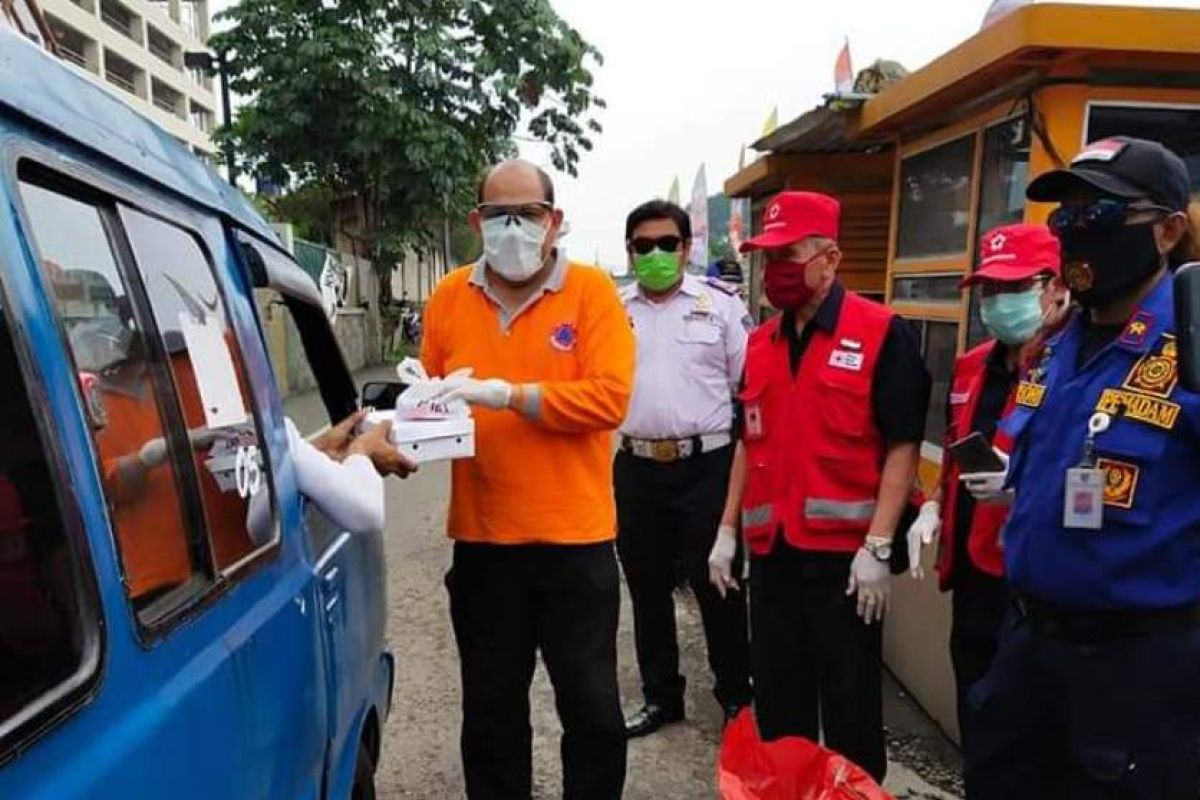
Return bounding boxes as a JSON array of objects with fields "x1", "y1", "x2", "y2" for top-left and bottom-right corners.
[{"x1": 5, "y1": 151, "x2": 282, "y2": 650}]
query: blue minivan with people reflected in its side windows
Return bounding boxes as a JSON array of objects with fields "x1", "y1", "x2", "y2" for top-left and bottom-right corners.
[{"x1": 0, "y1": 21, "x2": 395, "y2": 800}]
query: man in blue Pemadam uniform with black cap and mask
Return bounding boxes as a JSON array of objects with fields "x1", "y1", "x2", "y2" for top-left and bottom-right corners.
[{"x1": 965, "y1": 137, "x2": 1200, "y2": 800}]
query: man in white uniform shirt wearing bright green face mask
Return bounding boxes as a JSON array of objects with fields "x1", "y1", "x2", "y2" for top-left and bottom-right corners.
[{"x1": 613, "y1": 200, "x2": 751, "y2": 738}]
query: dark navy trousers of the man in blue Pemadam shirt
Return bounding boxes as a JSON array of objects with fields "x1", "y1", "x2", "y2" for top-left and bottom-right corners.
[{"x1": 965, "y1": 613, "x2": 1200, "y2": 800}]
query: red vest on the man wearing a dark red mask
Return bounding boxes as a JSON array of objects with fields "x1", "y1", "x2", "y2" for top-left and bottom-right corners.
[{"x1": 742, "y1": 291, "x2": 894, "y2": 555}]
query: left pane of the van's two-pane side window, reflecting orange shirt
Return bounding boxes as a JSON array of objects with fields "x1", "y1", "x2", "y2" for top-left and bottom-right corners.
[{"x1": 20, "y1": 182, "x2": 208, "y2": 624}]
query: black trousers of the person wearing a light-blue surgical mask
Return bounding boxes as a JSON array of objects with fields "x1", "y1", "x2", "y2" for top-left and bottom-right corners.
[{"x1": 950, "y1": 563, "x2": 1009, "y2": 748}]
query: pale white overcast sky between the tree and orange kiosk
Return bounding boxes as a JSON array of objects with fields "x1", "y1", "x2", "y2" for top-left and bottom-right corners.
[{"x1": 532, "y1": 0, "x2": 1200, "y2": 266}]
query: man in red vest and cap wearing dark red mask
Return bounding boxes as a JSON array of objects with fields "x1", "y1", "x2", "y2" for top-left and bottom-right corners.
[{"x1": 709, "y1": 192, "x2": 930, "y2": 780}]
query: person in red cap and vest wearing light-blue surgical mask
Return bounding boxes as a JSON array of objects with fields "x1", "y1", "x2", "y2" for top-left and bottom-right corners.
[{"x1": 908, "y1": 224, "x2": 1068, "y2": 753}]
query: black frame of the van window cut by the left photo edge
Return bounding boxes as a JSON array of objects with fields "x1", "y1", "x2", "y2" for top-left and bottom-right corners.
[{"x1": 0, "y1": 159, "x2": 108, "y2": 766}]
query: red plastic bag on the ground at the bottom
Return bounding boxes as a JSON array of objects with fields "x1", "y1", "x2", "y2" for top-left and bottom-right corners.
[{"x1": 716, "y1": 709, "x2": 894, "y2": 800}]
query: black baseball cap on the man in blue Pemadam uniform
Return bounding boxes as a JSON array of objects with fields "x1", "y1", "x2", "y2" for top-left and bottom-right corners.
[{"x1": 1025, "y1": 136, "x2": 1192, "y2": 211}]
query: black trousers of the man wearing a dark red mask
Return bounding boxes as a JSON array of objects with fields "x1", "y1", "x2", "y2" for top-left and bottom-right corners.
[{"x1": 750, "y1": 544, "x2": 887, "y2": 781}]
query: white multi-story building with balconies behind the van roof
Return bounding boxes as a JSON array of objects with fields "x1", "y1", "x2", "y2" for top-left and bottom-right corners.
[{"x1": 38, "y1": 0, "x2": 217, "y2": 157}]
